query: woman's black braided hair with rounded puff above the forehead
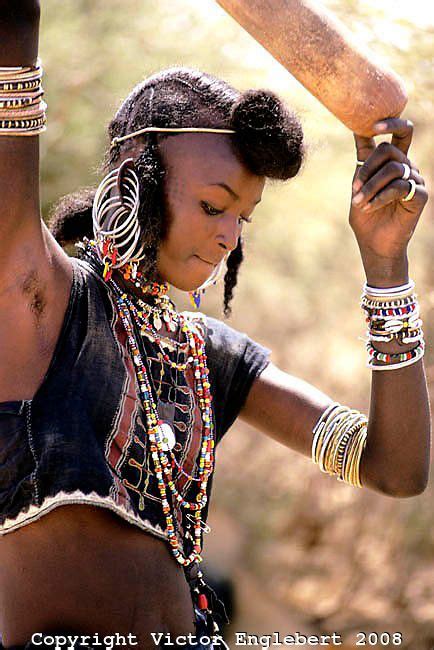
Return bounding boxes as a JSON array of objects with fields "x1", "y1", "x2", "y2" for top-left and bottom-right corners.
[{"x1": 49, "y1": 67, "x2": 304, "y2": 315}]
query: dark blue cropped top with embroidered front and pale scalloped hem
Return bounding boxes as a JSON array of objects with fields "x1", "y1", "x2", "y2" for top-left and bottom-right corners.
[{"x1": 0, "y1": 253, "x2": 269, "y2": 540}]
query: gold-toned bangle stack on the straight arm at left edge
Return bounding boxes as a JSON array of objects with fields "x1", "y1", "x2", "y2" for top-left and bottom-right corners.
[{"x1": 0, "y1": 60, "x2": 47, "y2": 136}]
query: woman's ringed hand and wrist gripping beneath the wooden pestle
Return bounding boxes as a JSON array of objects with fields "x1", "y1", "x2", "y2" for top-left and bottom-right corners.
[{"x1": 350, "y1": 118, "x2": 428, "y2": 286}]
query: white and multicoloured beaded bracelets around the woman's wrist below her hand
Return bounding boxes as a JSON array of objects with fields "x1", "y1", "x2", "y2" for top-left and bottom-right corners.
[{"x1": 361, "y1": 280, "x2": 425, "y2": 370}]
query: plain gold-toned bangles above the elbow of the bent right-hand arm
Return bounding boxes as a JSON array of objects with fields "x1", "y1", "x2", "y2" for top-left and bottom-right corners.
[{"x1": 312, "y1": 403, "x2": 368, "y2": 488}]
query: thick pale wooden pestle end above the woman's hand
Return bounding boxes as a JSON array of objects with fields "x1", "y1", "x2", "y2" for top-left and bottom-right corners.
[{"x1": 217, "y1": 0, "x2": 407, "y2": 136}]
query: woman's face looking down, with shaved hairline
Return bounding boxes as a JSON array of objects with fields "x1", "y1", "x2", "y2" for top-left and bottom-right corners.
[{"x1": 157, "y1": 133, "x2": 265, "y2": 291}]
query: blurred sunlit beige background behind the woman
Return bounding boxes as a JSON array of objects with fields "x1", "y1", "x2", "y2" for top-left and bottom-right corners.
[{"x1": 41, "y1": 0, "x2": 434, "y2": 650}]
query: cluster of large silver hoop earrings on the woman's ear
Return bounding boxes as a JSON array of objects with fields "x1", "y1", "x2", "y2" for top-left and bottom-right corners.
[{"x1": 92, "y1": 158, "x2": 146, "y2": 281}]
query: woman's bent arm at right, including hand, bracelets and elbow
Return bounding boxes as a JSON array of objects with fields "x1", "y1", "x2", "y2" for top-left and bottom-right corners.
[{"x1": 242, "y1": 118, "x2": 431, "y2": 497}]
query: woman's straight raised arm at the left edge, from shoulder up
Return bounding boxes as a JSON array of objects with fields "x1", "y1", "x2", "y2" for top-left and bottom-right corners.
[{"x1": 0, "y1": 0, "x2": 41, "y2": 258}]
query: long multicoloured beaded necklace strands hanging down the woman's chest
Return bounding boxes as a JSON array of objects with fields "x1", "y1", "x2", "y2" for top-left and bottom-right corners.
[{"x1": 77, "y1": 239, "x2": 215, "y2": 567}]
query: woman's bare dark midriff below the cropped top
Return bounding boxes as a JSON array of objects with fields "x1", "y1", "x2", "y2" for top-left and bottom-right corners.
[{"x1": 0, "y1": 505, "x2": 194, "y2": 650}]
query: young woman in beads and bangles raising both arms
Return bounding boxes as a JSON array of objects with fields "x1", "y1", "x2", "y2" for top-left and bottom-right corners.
[{"x1": 0, "y1": 0, "x2": 430, "y2": 648}]
